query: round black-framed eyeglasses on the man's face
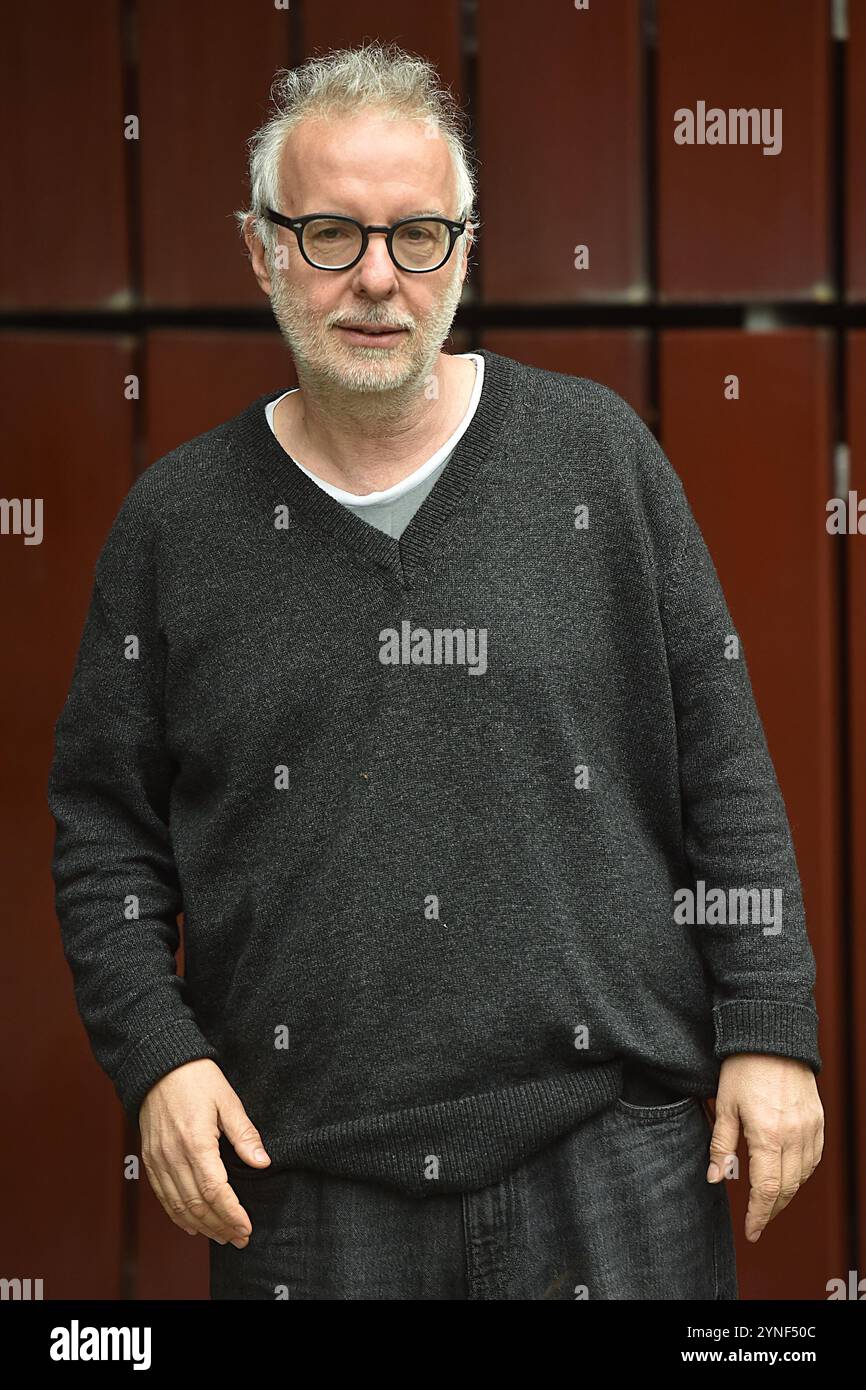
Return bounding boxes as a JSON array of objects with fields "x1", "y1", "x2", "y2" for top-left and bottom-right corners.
[{"x1": 264, "y1": 207, "x2": 466, "y2": 275}]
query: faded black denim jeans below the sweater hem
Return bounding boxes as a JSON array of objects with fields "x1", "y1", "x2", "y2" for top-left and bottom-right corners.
[{"x1": 210, "y1": 1073, "x2": 738, "y2": 1301}]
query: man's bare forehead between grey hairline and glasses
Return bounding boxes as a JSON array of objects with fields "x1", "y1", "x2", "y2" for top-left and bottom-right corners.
[{"x1": 279, "y1": 113, "x2": 456, "y2": 218}]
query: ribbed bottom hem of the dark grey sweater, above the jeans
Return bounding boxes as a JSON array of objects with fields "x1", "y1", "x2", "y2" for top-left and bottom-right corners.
[{"x1": 220, "y1": 1058, "x2": 623, "y2": 1197}]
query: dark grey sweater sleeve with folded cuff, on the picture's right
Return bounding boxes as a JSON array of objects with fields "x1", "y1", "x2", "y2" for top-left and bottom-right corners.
[{"x1": 653, "y1": 467, "x2": 822, "y2": 1073}]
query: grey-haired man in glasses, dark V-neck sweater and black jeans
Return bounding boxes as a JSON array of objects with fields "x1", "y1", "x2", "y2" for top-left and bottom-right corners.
[{"x1": 49, "y1": 44, "x2": 823, "y2": 1300}]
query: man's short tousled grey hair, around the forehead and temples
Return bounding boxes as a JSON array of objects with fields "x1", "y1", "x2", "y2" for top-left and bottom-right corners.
[{"x1": 235, "y1": 39, "x2": 477, "y2": 270}]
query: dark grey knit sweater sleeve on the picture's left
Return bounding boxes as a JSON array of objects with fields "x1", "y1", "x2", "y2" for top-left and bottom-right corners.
[{"x1": 47, "y1": 499, "x2": 217, "y2": 1122}]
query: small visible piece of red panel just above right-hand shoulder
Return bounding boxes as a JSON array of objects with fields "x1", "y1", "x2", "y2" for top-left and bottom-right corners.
[{"x1": 481, "y1": 328, "x2": 651, "y2": 420}]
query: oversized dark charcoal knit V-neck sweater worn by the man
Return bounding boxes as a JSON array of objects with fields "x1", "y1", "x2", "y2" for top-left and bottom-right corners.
[{"x1": 49, "y1": 350, "x2": 822, "y2": 1195}]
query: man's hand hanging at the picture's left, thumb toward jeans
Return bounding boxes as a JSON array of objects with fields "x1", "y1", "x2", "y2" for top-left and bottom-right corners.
[{"x1": 139, "y1": 1058, "x2": 271, "y2": 1250}]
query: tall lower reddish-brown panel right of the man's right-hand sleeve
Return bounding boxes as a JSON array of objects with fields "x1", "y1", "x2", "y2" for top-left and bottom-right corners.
[{"x1": 662, "y1": 329, "x2": 849, "y2": 1298}]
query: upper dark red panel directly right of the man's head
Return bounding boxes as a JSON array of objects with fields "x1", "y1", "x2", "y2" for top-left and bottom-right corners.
[{"x1": 477, "y1": 0, "x2": 648, "y2": 304}]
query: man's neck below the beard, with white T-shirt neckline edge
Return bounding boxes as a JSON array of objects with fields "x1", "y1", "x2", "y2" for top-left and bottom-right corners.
[{"x1": 274, "y1": 353, "x2": 475, "y2": 496}]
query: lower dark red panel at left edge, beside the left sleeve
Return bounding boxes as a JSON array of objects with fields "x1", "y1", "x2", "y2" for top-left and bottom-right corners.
[{"x1": 0, "y1": 334, "x2": 132, "y2": 1298}]
